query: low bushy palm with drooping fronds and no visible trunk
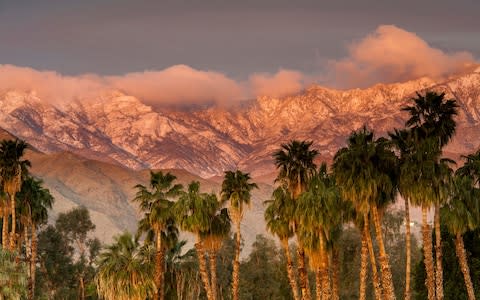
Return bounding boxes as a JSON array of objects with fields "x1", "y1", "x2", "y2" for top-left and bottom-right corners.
[{"x1": 95, "y1": 232, "x2": 157, "y2": 300}]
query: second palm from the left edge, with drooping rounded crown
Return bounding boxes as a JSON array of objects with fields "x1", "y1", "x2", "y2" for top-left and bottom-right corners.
[{"x1": 16, "y1": 176, "x2": 54, "y2": 299}]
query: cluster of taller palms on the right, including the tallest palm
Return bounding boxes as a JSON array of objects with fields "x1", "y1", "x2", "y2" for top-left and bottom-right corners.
[{"x1": 265, "y1": 92, "x2": 480, "y2": 300}]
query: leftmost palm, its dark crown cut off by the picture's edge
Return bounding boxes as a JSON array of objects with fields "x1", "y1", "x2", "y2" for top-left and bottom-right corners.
[{"x1": 0, "y1": 140, "x2": 30, "y2": 250}]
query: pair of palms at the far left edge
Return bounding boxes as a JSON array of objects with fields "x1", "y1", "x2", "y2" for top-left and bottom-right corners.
[{"x1": 0, "y1": 140, "x2": 54, "y2": 299}]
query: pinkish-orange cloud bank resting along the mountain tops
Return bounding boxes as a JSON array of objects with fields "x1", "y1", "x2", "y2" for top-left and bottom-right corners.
[{"x1": 0, "y1": 25, "x2": 477, "y2": 107}]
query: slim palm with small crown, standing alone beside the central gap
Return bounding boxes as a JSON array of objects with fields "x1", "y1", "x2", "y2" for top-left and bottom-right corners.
[{"x1": 221, "y1": 170, "x2": 258, "y2": 300}]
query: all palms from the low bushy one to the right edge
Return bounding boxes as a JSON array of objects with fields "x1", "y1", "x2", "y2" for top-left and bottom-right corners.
[{"x1": 97, "y1": 92, "x2": 480, "y2": 300}]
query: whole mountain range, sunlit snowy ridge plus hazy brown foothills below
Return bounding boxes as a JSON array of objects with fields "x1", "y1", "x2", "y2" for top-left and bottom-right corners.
[{"x1": 0, "y1": 69, "x2": 480, "y2": 250}]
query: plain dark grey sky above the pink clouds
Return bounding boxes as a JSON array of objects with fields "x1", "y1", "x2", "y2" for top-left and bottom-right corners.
[{"x1": 0, "y1": 0, "x2": 480, "y2": 80}]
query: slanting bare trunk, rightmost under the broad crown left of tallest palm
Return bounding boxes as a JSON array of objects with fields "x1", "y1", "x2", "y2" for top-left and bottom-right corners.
[{"x1": 372, "y1": 205, "x2": 395, "y2": 300}]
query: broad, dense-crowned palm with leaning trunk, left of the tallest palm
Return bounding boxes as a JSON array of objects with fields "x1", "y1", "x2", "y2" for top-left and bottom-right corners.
[{"x1": 333, "y1": 127, "x2": 397, "y2": 299}]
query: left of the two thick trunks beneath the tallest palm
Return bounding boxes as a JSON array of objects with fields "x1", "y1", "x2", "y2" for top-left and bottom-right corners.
[{"x1": 422, "y1": 206, "x2": 436, "y2": 300}]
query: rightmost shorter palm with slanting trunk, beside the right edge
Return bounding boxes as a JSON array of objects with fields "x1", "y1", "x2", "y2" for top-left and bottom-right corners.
[{"x1": 442, "y1": 172, "x2": 480, "y2": 300}]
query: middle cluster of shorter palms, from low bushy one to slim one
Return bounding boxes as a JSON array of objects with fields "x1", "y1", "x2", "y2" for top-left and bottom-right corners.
[{"x1": 96, "y1": 171, "x2": 257, "y2": 300}]
